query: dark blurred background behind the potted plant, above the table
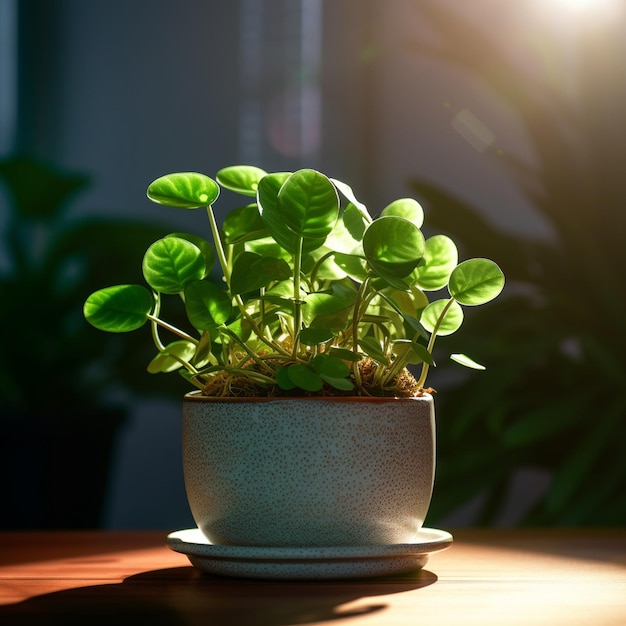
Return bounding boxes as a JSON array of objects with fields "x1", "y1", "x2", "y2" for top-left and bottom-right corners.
[{"x1": 0, "y1": 0, "x2": 626, "y2": 529}]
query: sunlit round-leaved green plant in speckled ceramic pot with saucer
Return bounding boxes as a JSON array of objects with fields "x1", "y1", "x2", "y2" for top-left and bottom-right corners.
[{"x1": 84, "y1": 165, "x2": 504, "y2": 576}]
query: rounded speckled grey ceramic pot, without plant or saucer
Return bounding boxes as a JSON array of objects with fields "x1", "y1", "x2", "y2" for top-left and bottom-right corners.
[{"x1": 183, "y1": 394, "x2": 435, "y2": 547}]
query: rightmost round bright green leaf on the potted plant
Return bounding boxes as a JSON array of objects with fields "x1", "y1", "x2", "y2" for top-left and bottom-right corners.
[{"x1": 448, "y1": 259, "x2": 504, "y2": 306}]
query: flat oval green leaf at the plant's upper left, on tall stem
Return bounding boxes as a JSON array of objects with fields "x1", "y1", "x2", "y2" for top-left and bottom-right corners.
[{"x1": 148, "y1": 172, "x2": 220, "y2": 209}]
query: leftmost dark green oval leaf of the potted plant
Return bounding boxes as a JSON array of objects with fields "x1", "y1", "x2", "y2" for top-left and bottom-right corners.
[{"x1": 83, "y1": 285, "x2": 154, "y2": 333}]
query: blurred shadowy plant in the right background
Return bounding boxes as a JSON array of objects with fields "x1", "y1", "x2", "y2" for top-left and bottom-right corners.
[{"x1": 412, "y1": 2, "x2": 626, "y2": 526}]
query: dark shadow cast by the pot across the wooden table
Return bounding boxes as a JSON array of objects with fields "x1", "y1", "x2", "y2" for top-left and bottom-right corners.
[{"x1": 0, "y1": 567, "x2": 437, "y2": 626}]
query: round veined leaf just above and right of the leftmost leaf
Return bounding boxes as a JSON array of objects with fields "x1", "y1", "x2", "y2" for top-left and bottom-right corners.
[{"x1": 143, "y1": 237, "x2": 207, "y2": 294}]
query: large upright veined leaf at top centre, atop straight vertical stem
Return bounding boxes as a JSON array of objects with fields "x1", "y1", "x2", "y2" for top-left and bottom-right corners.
[{"x1": 277, "y1": 170, "x2": 339, "y2": 239}]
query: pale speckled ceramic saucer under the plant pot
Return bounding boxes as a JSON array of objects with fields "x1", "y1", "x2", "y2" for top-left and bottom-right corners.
[{"x1": 166, "y1": 528, "x2": 452, "y2": 580}]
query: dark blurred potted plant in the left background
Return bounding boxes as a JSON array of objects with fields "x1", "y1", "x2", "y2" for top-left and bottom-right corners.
[{"x1": 0, "y1": 156, "x2": 172, "y2": 529}]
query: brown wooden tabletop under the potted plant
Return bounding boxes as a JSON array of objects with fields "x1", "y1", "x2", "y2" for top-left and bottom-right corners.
[{"x1": 0, "y1": 530, "x2": 626, "y2": 626}]
